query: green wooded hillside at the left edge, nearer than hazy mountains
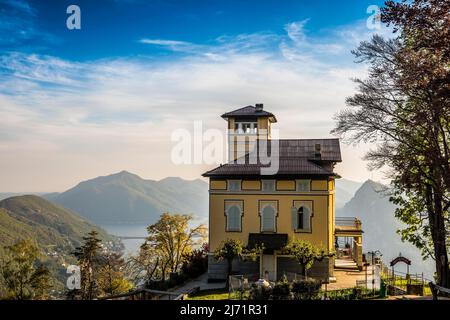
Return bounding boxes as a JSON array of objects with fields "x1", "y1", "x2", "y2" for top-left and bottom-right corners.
[{"x1": 0, "y1": 195, "x2": 122, "y2": 294}]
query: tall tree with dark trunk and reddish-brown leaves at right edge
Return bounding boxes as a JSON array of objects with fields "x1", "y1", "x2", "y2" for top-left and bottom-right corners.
[{"x1": 333, "y1": 0, "x2": 450, "y2": 287}]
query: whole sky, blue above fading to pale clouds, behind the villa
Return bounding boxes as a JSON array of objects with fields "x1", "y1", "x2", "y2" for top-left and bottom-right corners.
[{"x1": 0, "y1": 0, "x2": 390, "y2": 191}]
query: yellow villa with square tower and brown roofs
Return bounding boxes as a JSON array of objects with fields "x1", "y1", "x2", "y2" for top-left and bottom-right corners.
[{"x1": 203, "y1": 104, "x2": 361, "y2": 280}]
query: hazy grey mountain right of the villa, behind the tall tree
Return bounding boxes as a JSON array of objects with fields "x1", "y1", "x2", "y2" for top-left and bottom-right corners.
[{"x1": 336, "y1": 180, "x2": 434, "y2": 279}]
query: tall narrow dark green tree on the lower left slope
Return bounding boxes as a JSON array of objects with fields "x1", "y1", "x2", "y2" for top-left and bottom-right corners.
[{"x1": 74, "y1": 230, "x2": 102, "y2": 300}]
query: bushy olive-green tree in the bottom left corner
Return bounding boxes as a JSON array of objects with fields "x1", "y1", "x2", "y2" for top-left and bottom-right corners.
[{"x1": 0, "y1": 240, "x2": 51, "y2": 300}]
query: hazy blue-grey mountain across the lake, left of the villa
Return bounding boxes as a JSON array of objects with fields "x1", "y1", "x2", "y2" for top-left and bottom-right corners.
[{"x1": 52, "y1": 171, "x2": 208, "y2": 225}]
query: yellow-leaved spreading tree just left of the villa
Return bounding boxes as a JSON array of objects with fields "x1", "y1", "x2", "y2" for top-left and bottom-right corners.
[{"x1": 146, "y1": 213, "x2": 206, "y2": 280}]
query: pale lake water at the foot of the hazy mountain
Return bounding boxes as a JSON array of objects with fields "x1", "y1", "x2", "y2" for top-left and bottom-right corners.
[{"x1": 101, "y1": 224, "x2": 147, "y2": 255}]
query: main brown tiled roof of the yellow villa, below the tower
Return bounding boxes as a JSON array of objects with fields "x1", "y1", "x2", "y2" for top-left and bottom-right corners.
[{"x1": 203, "y1": 139, "x2": 341, "y2": 177}]
